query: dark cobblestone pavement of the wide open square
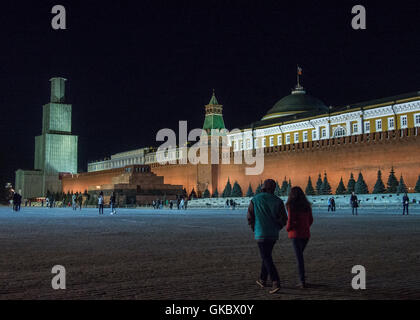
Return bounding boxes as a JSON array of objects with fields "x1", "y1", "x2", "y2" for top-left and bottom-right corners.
[{"x1": 0, "y1": 207, "x2": 420, "y2": 300}]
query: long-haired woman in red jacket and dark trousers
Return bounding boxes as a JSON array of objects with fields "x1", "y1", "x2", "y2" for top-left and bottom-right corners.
[{"x1": 286, "y1": 187, "x2": 314, "y2": 288}]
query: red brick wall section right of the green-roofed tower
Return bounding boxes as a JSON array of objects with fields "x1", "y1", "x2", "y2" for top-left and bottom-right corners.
[{"x1": 218, "y1": 128, "x2": 420, "y2": 193}]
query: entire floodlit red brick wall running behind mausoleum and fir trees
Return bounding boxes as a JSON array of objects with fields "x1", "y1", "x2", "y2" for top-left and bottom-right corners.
[{"x1": 63, "y1": 128, "x2": 420, "y2": 194}]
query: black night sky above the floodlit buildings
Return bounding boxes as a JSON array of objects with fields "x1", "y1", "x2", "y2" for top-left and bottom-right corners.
[{"x1": 0, "y1": 0, "x2": 420, "y2": 183}]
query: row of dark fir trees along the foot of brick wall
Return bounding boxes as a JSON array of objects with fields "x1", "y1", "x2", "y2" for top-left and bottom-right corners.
[{"x1": 199, "y1": 168, "x2": 420, "y2": 198}]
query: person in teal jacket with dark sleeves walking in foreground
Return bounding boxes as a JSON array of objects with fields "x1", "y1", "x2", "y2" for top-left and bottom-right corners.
[{"x1": 247, "y1": 179, "x2": 287, "y2": 293}]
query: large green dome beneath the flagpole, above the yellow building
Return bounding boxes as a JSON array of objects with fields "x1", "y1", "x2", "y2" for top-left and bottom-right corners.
[{"x1": 262, "y1": 87, "x2": 328, "y2": 120}]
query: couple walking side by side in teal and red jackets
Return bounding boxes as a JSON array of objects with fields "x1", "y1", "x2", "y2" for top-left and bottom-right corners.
[{"x1": 247, "y1": 179, "x2": 313, "y2": 293}]
